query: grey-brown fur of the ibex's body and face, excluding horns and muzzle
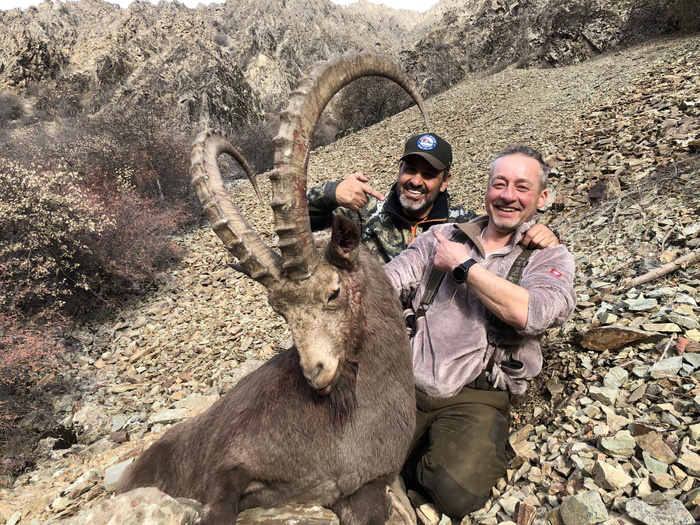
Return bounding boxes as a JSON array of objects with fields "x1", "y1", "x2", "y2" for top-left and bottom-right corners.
[{"x1": 117, "y1": 214, "x2": 415, "y2": 525}]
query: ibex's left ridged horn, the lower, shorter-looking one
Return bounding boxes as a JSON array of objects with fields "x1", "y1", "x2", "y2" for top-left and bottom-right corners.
[{"x1": 190, "y1": 129, "x2": 282, "y2": 287}]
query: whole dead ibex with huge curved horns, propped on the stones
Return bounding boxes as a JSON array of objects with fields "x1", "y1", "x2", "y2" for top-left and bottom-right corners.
[{"x1": 117, "y1": 52, "x2": 427, "y2": 525}]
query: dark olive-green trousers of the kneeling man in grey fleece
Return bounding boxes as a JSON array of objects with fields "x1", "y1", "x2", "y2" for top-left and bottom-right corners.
[{"x1": 403, "y1": 385, "x2": 510, "y2": 519}]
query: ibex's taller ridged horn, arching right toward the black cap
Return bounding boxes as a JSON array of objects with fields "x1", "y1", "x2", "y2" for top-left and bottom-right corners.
[{"x1": 270, "y1": 51, "x2": 430, "y2": 281}]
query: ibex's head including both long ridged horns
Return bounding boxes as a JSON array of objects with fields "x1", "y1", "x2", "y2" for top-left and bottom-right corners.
[{"x1": 191, "y1": 52, "x2": 430, "y2": 395}]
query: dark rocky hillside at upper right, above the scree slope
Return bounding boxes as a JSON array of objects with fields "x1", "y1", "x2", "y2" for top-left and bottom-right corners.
[{"x1": 401, "y1": 0, "x2": 700, "y2": 93}]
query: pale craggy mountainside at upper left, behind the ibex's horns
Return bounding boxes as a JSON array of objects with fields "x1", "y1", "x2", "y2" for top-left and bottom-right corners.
[{"x1": 0, "y1": 0, "x2": 415, "y2": 128}]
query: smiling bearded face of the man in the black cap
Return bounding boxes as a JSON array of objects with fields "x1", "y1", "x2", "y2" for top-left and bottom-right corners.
[{"x1": 396, "y1": 155, "x2": 450, "y2": 219}]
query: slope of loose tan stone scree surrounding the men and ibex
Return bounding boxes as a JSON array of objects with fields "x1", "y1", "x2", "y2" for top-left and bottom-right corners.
[{"x1": 0, "y1": 33, "x2": 700, "y2": 525}]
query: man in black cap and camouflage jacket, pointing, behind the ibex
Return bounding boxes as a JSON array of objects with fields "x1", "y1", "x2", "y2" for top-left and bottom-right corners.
[{"x1": 308, "y1": 133, "x2": 558, "y2": 263}]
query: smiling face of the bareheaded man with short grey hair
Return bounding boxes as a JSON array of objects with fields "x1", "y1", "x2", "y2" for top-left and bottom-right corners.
[{"x1": 486, "y1": 153, "x2": 547, "y2": 234}]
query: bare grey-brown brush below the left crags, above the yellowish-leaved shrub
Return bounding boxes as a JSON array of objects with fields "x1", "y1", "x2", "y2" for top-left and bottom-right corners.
[{"x1": 0, "y1": 105, "x2": 199, "y2": 211}]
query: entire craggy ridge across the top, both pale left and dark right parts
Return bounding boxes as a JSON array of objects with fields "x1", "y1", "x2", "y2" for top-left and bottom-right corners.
[{"x1": 0, "y1": 0, "x2": 692, "y2": 133}]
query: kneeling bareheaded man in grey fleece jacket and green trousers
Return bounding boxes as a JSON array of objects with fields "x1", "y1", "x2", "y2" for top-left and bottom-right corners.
[{"x1": 384, "y1": 145, "x2": 576, "y2": 518}]
